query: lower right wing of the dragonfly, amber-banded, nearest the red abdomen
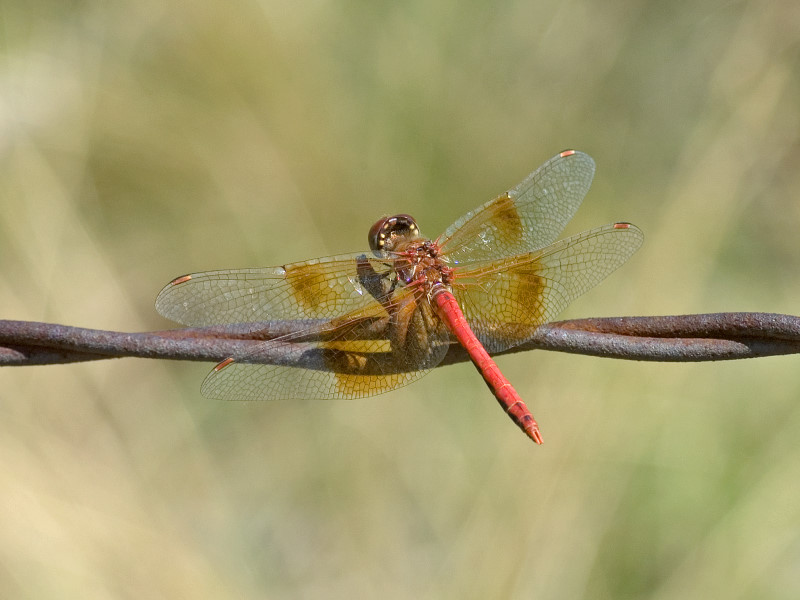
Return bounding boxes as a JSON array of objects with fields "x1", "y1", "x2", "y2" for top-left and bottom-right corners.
[{"x1": 453, "y1": 223, "x2": 644, "y2": 352}]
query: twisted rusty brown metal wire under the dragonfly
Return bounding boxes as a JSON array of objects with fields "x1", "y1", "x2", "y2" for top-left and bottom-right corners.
[{"x1": 0, "y1": 313, "x2": 800, "y2": 367}]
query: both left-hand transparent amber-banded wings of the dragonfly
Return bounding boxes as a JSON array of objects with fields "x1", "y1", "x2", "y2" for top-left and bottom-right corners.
[{"x1": 156, "y1": 254, "x2": 449, "y2": 400}]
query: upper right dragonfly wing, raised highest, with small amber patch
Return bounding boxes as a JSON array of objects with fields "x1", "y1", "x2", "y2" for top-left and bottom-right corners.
[{"x1": 439, "y1": 150, "x2": 594, "y2": 265}]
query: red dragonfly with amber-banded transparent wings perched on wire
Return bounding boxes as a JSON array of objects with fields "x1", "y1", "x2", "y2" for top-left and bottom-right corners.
[{"x1": 156, "y1": 150, "x2": 643, "y2": 444}]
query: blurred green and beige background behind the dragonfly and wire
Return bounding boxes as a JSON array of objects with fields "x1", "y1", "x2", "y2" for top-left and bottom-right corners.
[{"x1": 0, "y1": 0, "x2": 800, "y2": 600}]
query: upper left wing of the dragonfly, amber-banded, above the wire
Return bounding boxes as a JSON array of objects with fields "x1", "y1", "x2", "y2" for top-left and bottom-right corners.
[{"x1": 156, "y1": 254, "x2": 398, "y2": 327}]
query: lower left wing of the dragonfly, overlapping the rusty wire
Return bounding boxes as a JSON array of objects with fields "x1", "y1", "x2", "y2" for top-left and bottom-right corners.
[{"x1": 196, "y1": 290, "x2": 450, "y2": 400}]
